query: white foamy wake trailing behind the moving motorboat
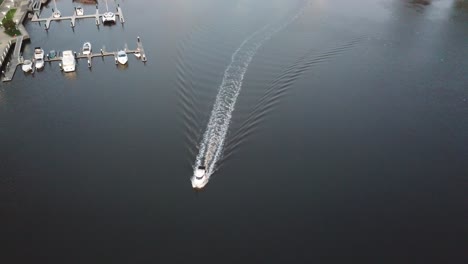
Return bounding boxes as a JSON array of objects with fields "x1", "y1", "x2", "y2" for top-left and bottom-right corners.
[{"x1": 194, "y1": 1, "x2": 305, "y2": 186}]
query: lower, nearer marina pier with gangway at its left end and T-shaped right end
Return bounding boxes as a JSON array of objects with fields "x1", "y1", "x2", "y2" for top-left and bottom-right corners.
[{"x1": 3, "y1": 36, "x2": 147, "y2": 82}]
